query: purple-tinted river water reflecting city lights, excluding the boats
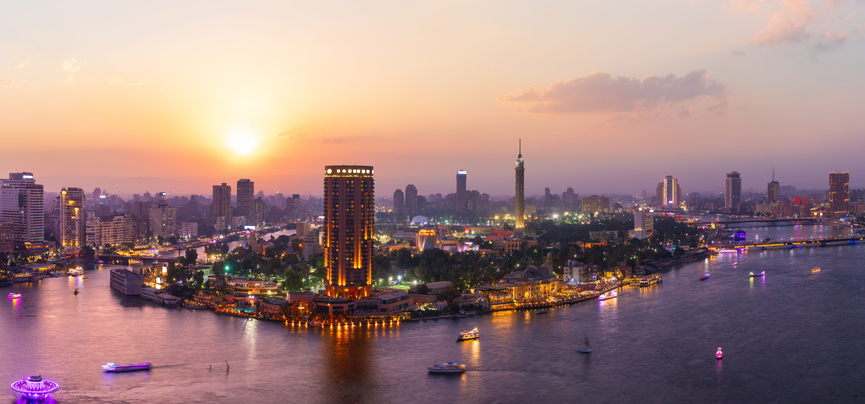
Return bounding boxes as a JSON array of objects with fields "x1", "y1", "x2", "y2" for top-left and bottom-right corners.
[{"x1": 0, "y1": 227, "x2": 865, "y2": 403}]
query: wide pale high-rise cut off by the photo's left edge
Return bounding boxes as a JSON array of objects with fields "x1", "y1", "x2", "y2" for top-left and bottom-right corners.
[{"x1": 0, "y1": 172, "x2": 45, "y2": 246}]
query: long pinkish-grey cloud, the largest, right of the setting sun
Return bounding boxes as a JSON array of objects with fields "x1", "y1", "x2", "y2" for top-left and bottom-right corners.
[{"x1": 498, "y1": 70, "x2": 728, "y2": 115}]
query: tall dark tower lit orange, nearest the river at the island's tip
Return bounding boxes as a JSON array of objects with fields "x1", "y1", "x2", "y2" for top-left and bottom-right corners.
[{"x1": 322, "y1": 165, "x2": 375, "y2": 299}]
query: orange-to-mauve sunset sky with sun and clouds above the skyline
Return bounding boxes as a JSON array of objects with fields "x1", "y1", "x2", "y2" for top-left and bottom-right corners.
[{"x1": 0, "y1": 0, "x2": 865, "y2": 196}]
